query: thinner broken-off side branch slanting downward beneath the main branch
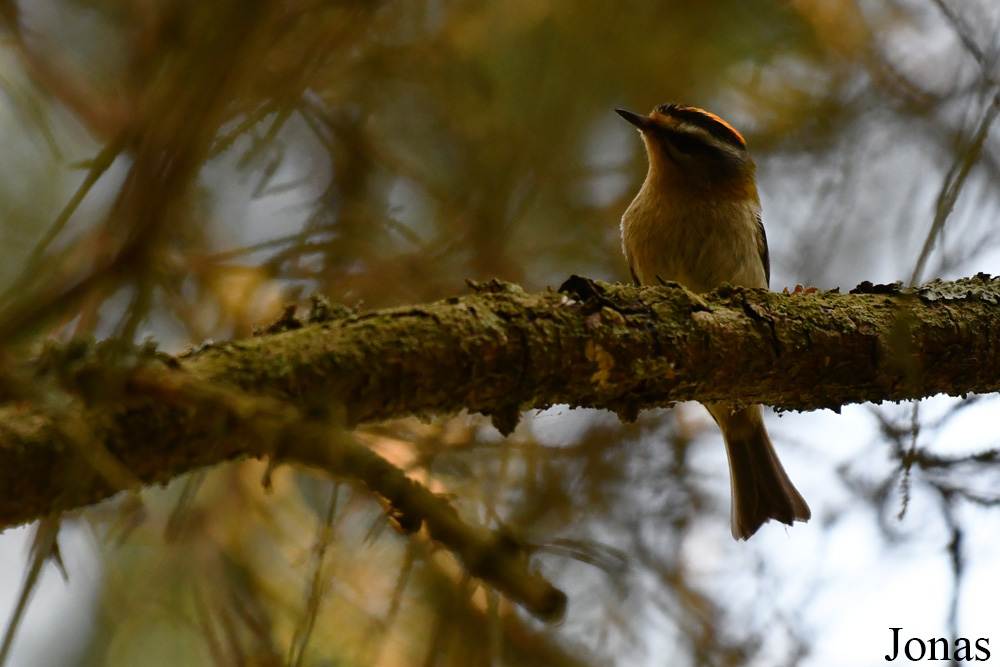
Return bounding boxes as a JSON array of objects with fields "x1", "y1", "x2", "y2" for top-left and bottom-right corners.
[{"x1": 0, "y1": 364, "x2": 566, "y2": 620}]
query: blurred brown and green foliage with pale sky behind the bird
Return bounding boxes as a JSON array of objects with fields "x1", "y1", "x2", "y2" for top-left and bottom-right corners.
[{"x1": 0, "y1": 0, "x2": 1000, "y2": 666}]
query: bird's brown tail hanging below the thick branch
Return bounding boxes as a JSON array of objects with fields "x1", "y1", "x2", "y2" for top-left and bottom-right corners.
[{"x1": 706, "y1": 403, "x2": 812, "y2": 540}]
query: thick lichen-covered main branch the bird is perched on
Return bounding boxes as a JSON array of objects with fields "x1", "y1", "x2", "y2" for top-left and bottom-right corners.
[{"x1": 0, "y1": 275, "x2": 1000, "y2": 576}]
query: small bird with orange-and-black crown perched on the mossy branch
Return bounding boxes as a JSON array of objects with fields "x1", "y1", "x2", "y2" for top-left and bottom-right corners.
[{"x1": 615, "y1": 104, "x2": 811, "y2": 540}]
